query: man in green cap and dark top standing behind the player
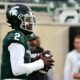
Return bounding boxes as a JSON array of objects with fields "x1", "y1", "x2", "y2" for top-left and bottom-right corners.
[{"x1": 28, "y1": 33, "x2": 54, "y2": 80}]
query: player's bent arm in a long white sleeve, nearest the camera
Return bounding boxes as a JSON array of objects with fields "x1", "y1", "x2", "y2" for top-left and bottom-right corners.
[{"x1": 8, "y1": 43, "x2": 44, "y2": 76}]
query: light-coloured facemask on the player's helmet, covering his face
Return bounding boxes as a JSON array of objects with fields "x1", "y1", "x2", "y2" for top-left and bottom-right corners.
[{"x1": 18, "y1": 12, "x2": 36, "y2": 32}]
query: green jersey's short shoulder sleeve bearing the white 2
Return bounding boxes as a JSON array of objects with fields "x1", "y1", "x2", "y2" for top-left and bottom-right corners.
[{"x1": 4, "y1": 31, "x2": 26, "y2": 45}]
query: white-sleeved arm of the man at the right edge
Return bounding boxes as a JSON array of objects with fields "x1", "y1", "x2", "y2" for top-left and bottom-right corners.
[{"x1": 63, "y1": 55, "x2": 72, "y2": 80}]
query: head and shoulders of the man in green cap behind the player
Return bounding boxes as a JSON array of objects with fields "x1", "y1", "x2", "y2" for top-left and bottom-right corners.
[{"x1": 28, "y1": 33, "x2": 44, "y2": 54}]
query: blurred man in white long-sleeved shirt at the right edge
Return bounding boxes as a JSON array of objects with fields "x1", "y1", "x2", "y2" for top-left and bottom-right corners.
[{"x1": 64, "y1": 33, "x2": 80, "y2": 80}]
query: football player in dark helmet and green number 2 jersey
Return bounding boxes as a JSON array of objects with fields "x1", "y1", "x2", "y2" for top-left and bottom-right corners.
[{"x1": 1, "y1": 4, "x2": 53, "y2": 80}]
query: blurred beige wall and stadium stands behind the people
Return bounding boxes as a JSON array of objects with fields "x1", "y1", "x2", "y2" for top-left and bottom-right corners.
[{"x1": 0, "y1": 0, "x2": 80, "y2": 80}]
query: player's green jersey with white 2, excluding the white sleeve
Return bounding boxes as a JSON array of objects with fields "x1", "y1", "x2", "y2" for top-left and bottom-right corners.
[{"x1": 1, "y1": 30, "x2": 31, "y2": 79}]
